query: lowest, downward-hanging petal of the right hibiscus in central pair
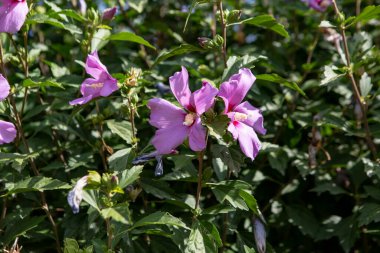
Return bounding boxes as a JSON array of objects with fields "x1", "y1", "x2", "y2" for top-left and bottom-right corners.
[{"x1": 233, "y1": 121, "x2": 261, "y2": 160}]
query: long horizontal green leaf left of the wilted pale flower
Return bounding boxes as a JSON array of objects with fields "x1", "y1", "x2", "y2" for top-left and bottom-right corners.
[{"x1": 4, "y1": 176, "x2": 71, "y2": 196}]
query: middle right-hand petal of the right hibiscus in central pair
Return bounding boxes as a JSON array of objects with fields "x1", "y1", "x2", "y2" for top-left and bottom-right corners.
[{"x1": 234, "y1": 102, "x2": 267, "y2": 134}]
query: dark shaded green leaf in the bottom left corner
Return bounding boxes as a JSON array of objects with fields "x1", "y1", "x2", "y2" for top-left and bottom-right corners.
[{"x1": 0, "y1": 216, "x2": 45, "y2": 244}]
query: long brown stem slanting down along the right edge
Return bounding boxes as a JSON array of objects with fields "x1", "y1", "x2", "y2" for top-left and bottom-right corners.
[{"x1": 332, "y1": 0, "x2": 377, "y2": 160}]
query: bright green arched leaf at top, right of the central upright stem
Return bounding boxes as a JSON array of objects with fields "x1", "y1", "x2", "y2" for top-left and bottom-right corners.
[{"x1": 229, "y1": 14, "x2": 289, "y2": 38}]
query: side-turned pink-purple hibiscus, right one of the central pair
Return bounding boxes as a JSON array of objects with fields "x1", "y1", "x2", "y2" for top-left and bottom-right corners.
[{"x1": 218, "y1": 68, "x2": 266, "y2": 160}]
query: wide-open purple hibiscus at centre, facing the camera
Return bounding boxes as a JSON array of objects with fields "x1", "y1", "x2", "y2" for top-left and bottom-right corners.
[{"x1": 148, "y1": 67, "x2": 218, "y2": 154}]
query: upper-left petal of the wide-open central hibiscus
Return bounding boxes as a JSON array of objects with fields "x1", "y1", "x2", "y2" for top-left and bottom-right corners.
[{"x1": 148, "y1": 98, "x2": 186, "y2": 128}]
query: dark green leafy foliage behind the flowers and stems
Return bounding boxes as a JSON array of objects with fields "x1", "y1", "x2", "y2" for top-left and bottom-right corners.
[{"x1": 0, "y1": 0, "x2": 380, "y2": 253}]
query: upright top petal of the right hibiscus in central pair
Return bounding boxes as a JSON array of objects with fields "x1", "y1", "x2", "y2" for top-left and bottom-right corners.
[{"x1": 218, "y1": 68, "x2": 256, "y2": 112}]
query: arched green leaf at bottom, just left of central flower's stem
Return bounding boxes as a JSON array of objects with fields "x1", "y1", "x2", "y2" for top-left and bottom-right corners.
[{"x1": 129, "y1": 211, "x2": 189, "y2": 230}]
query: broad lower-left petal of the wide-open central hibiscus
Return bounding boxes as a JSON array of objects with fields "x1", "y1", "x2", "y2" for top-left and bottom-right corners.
[{"x1": 152, "y1": 124, "x2": 189, "y2": 154}]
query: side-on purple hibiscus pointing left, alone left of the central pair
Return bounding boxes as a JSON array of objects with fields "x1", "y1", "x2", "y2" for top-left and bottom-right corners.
[{"x1": 70, "y1": 51, "x2": 119, "y2": 105}]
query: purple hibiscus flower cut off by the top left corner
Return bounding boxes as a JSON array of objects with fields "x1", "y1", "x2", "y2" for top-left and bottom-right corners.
[{"x1": 0, "y1": 0, "x2": 29, "y2": 33}]
